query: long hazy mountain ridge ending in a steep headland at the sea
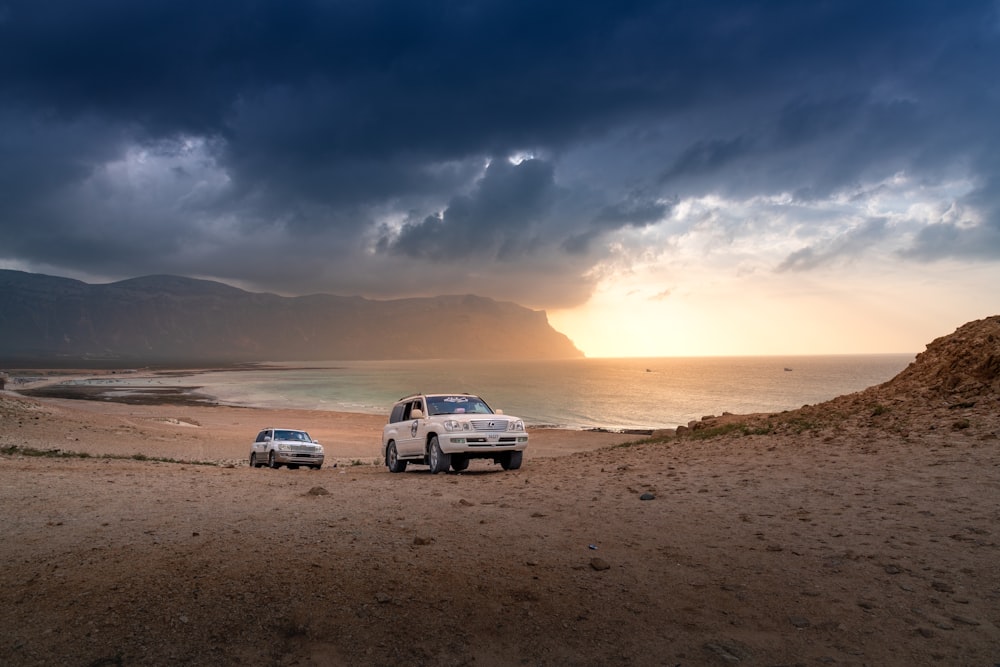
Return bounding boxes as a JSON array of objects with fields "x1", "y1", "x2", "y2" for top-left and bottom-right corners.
[{"x1": 0, "y1": 270, "x2": 582, "y2": 364}]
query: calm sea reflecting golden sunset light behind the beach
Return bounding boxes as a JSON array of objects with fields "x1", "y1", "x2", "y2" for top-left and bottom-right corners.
[{"x1": 107, "y1": 353, "x2": 915, "y2": 431}]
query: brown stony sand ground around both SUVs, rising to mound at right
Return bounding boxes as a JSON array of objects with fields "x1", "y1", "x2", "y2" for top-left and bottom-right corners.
[{"x1": 0, "y1": 317, "x2": 1000, "y2": 666}]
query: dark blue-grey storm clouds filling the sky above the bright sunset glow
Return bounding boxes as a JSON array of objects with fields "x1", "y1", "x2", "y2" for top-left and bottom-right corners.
[{"x1": 0, "y1": 0, "x2": 1000, "y2": 305}]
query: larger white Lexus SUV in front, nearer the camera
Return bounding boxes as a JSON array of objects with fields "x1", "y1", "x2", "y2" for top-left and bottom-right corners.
[{"x1": 382, "y1": 394, "x2": 528, "y2": 474}]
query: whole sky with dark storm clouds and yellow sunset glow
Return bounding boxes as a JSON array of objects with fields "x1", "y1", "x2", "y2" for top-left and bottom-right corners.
[{"x1": 0, "y1": 0, "x2": 1000, "y2": 357}]
